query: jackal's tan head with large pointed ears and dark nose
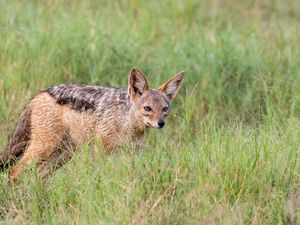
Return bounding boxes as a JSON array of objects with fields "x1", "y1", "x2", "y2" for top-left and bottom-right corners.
[{"x1": 128, "y1": 68, "x2": 184, "y2": 129}]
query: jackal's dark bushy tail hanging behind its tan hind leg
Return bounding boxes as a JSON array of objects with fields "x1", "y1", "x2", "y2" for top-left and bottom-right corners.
[{"x1": 0, "y1": 106, "x2": 31, "y2": 170}]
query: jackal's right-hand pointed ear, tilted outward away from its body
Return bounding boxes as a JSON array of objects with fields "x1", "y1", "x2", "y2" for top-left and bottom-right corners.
[{"x1": 158, "y1": 71, "x2": 184, "y2": 101}]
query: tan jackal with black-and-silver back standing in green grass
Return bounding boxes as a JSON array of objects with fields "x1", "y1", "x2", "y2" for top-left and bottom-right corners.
[{"x1": 0, "y1": 67, "x2": 184, "y2": 180}]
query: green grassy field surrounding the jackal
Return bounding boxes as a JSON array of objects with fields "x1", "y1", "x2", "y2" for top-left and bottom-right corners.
[{"x1": 0, "y1": 0, "x2": 300, "y2": 225}]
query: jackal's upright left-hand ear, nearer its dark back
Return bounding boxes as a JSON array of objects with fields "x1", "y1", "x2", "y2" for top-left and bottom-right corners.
[{"x1": 128, "y1": 67, "x2": 149, "y2": 101}]
